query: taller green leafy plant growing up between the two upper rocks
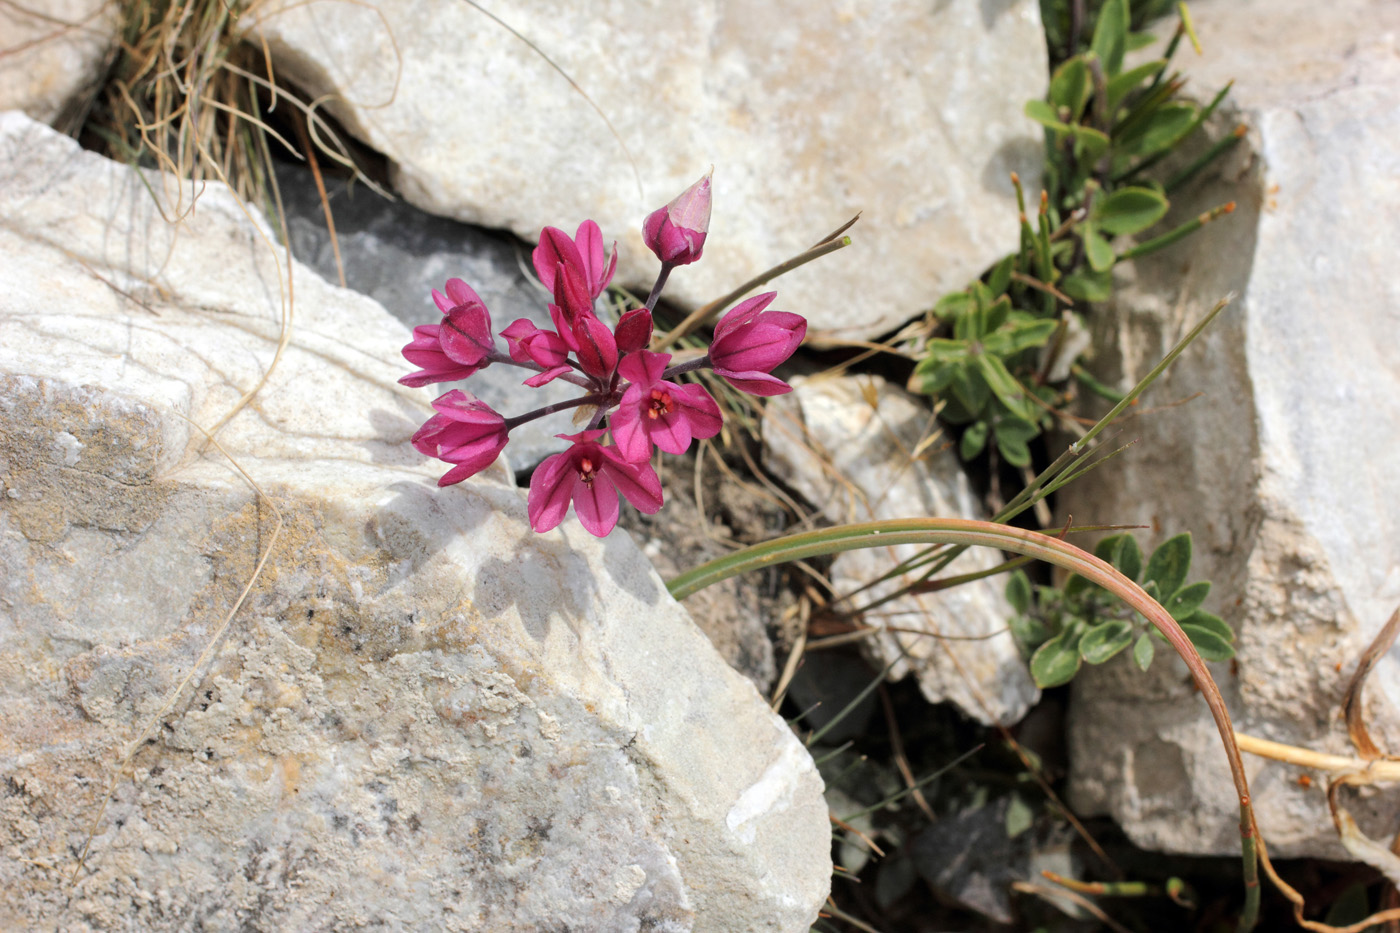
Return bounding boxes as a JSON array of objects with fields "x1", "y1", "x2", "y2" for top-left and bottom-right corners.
[{"x1": 909, "y1": 0, "x2": 1243, "y2": 467}]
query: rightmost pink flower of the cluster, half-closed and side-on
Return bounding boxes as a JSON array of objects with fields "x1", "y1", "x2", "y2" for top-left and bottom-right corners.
[{"x1": 710, "y1": 291, "x2": 806, "y2": 395}]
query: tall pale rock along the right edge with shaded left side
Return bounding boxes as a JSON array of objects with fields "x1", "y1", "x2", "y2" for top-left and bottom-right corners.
[{"x1": 1060, "y1": 0, "x2": 1400, "y2": 857}]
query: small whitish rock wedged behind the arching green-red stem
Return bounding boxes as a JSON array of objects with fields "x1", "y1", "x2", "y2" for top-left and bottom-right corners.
[{"x1": 763, "y1": 377, "x2": 1040, "y2": 724}]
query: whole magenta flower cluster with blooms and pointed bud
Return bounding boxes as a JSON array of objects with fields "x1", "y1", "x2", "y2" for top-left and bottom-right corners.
[{"x1": 399, "y1": 175, "x2": 806, "y2": 537}]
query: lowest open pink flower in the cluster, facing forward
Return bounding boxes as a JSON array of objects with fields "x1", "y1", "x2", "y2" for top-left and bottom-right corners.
[{"x1": 528, "y1": 430, "x2": 662, "y2": 538}]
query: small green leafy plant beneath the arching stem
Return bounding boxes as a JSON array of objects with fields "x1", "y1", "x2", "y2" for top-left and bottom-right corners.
[{"x1": 1007, "y1": 534, "x2": 1235, "y2": 688}]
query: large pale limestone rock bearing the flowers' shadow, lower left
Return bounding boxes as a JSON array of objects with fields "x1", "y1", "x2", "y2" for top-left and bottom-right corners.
[{"x1": 0, "y1": 113, "x2": 830, "y2": 932}]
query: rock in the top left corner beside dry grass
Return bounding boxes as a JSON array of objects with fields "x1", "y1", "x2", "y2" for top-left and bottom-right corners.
[{"x1": 0, "y1": 0, "x2": 120, "y2": 125}]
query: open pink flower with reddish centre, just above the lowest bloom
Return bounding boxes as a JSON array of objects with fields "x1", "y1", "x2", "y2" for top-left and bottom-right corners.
[{"x1": 612, "y1": 350, "x2": 724, "y2": 461}]
